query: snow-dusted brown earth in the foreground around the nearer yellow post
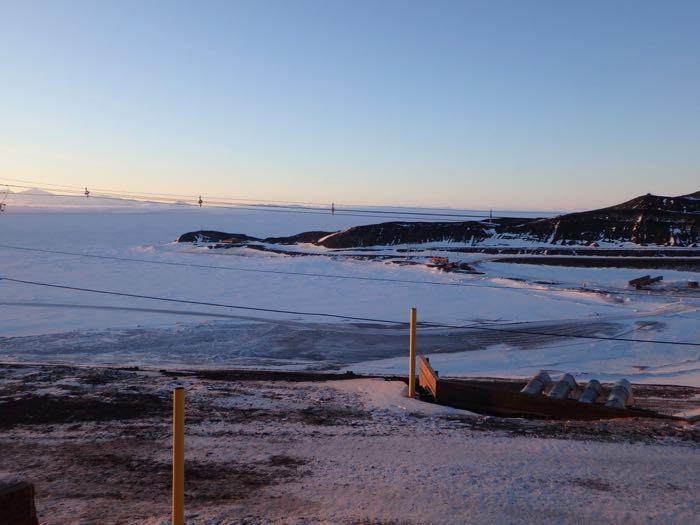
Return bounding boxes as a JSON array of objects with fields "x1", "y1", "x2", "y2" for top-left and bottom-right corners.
[{"x1": 0, "y1": 365, "x2": 700, "y2": 524}]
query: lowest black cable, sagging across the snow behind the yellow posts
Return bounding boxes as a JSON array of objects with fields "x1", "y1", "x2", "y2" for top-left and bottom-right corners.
[{"x1": 0, "y1": 276, "x2": 700, "y2": 346}]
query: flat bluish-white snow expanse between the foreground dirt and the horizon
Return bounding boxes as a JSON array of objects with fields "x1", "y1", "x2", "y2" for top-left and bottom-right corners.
[{"x1": 0, "y1": 195, "x2": 700, "y2": 385}]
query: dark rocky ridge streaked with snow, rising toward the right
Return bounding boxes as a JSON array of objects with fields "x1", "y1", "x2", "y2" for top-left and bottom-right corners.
[{"x1": 178, "y1": 192, "x2": 700, "y2": 248}]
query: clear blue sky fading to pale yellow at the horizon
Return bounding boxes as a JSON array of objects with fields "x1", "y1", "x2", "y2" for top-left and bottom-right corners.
[{"x1": 0, "y1": 0, "x2": 700, "y2": 210}]
